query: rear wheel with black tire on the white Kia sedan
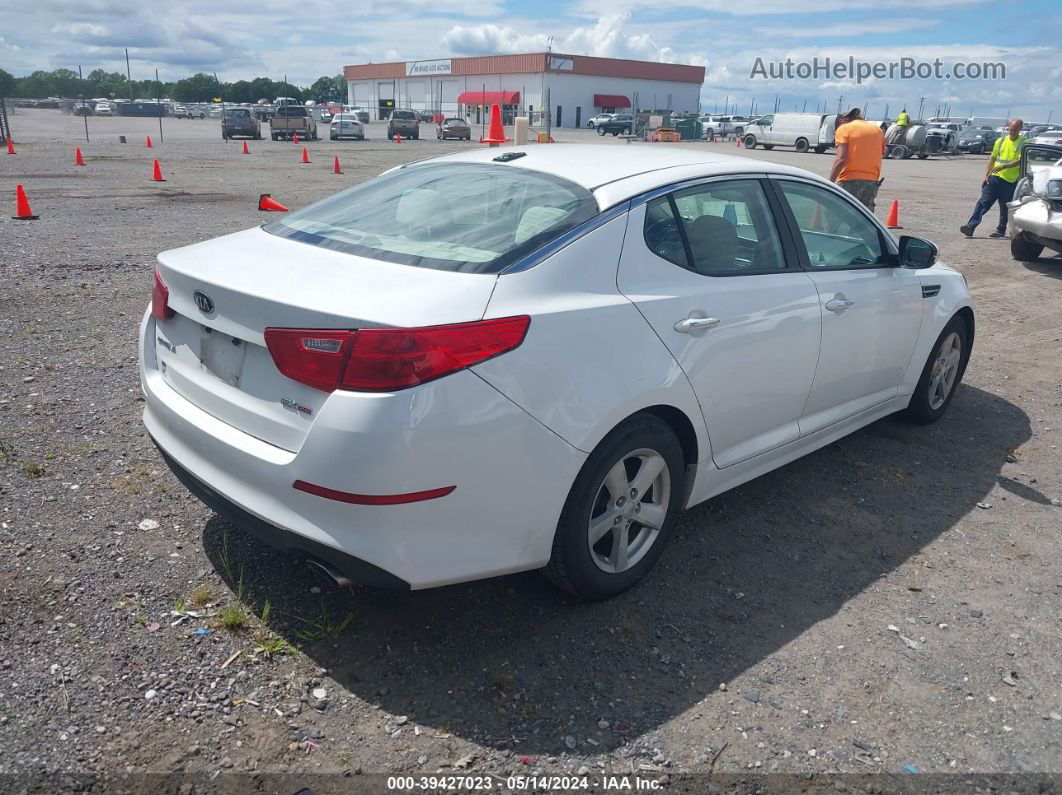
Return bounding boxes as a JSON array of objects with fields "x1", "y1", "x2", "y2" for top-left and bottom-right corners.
[{"x1": 544, "y1": 414, "x2": 686, "y2": 600}]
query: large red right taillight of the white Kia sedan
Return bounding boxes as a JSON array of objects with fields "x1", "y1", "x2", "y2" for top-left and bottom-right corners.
[{"x1": 264, "y1": 315, "x2": 531, "y2": 392}]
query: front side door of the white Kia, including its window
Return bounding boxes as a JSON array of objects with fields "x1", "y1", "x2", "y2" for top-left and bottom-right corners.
[{"x1": 772, "y1": 178, "x2": 924, "y2": 435}]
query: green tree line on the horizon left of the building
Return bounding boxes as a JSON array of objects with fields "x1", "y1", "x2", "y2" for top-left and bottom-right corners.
[{"x1": 0, "y1": 69, "x2": 346, "y2": 103}]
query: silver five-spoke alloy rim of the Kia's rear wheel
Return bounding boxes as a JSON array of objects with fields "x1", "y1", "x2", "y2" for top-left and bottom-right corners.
[{"x1": 586, "y1": 448, "x2": 671, "y2": 574}]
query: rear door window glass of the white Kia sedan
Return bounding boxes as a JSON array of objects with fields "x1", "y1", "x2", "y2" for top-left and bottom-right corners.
[{"x1": 646, "y1": 179, "x2": 786, "y2": 276}]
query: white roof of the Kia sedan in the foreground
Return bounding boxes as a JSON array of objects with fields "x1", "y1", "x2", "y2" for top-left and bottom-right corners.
[{"x1": 410, "y1": 143, "x2": 822, "y2": 208}]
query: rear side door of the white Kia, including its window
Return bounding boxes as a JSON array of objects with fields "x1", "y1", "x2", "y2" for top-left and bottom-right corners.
[{"x1": 617, "y1": 177, "x2": 821, "y2": 467}]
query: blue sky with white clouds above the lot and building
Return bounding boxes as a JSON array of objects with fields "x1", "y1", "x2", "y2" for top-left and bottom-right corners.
[{"x1": 6, "y1": 0, "x2": 1062, "y2": 120}]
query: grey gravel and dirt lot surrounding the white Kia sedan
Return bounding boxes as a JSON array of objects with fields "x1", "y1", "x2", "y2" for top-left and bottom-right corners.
[{"x1": 0, "y1": 110, "x2": 1062, "y2": 792}]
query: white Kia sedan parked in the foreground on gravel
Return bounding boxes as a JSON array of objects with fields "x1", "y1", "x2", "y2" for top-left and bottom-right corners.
[{"x1": 140, "y1": 144, "x2": 974, "y2": 599}]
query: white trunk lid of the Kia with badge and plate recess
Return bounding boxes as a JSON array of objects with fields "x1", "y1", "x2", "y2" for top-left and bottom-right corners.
[{"x1": 155, "y1": 228, "x2": 497, "y2": 451}]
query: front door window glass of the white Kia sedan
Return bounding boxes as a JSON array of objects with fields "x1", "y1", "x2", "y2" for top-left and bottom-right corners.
[{"x1": 778, "y1": 179, "x2": 889, "y2": 270}]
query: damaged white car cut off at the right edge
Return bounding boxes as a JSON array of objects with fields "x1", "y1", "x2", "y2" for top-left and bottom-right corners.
[{"x1": 1008, "y1": 144, "x2": 1062, "y2": 262}]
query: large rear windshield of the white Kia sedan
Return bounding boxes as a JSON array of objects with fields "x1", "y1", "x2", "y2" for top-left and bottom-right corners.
[{"x1": 264, "y1": 163, "x2": 598, "y2": 273}]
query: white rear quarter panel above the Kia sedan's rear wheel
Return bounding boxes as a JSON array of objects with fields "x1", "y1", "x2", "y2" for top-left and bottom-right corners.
[{"x1": 474, "y1": 213, "x2": 710, "y2": 469}]
